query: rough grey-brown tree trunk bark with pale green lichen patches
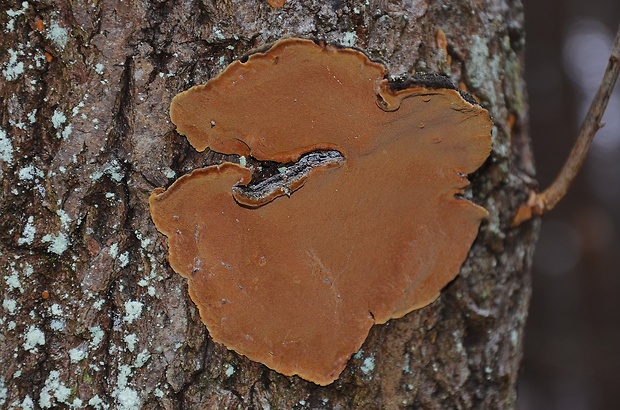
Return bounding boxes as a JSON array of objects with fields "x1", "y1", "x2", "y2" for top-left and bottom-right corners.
[{"x1": 0, "y1": 0, "x2": 538, "y2": 409}]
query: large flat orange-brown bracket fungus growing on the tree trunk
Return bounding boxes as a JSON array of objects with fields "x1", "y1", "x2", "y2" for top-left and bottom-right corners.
[{"x1": 149, "y1": 39, "x2": 492, "y2": 385}]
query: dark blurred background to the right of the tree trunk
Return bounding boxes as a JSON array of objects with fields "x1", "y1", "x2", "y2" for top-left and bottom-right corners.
[{"x1": 519, "y1": 0, "x2": 620, "y2": 410}]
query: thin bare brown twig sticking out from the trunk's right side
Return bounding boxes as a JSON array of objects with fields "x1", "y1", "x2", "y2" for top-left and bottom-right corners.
[{"x1": 511, "y1": 27, "x2": 620, "y2": 227}]
